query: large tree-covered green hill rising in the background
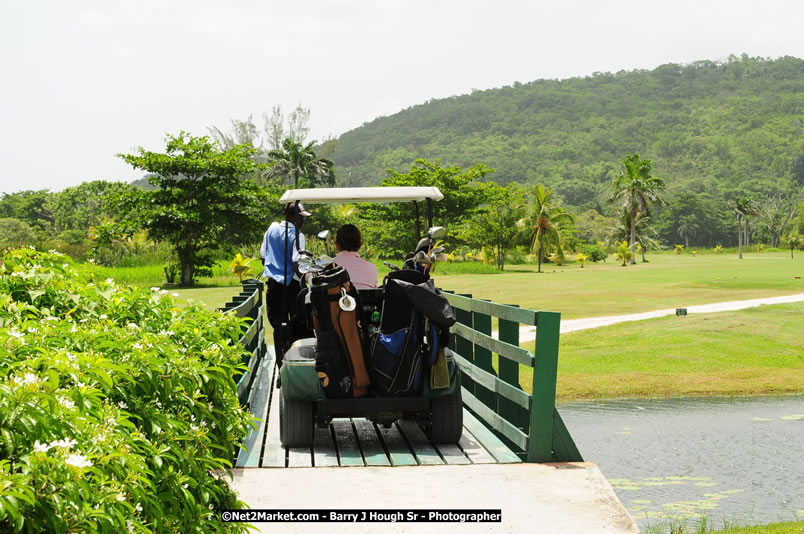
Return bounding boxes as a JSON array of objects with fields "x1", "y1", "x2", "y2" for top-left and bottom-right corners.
[{"x1": 332, "y1": 55, "x2": 804, "y2": 203}]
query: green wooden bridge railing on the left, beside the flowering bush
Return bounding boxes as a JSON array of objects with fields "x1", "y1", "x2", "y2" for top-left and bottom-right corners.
[{"x1": 220, "y1": 280, "x2": 268, "y2": 407}]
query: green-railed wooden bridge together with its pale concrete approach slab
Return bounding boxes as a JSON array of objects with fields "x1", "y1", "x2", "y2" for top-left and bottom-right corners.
[{"x1": 225, "y1": 282, "x2": 639, "y2": 534}]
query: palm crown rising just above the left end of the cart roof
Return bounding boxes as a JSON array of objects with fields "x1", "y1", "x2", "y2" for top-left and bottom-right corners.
[{"x1": 268, "y1": 137, "x2": 335, "y2": 188}]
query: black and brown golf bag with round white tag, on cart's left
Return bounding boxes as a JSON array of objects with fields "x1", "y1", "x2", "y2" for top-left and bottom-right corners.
[{"x1": 309, "y1": 267, "x2": 371, "y2": 398}]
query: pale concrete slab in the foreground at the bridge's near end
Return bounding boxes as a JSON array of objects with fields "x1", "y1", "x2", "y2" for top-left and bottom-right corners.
[{"x1": 231, "y1": 462, "x2": 639, "y2": 534}]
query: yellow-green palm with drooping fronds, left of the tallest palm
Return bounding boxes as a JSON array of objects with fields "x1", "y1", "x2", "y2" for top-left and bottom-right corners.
[{"x1": 517, "y1": 185, "x2": 575, "y2": 272}]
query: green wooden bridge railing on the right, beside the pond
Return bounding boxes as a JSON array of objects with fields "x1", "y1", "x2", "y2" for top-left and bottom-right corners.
[{"x1": 444, "y1": 292, "x2": 583, "y2": 463}]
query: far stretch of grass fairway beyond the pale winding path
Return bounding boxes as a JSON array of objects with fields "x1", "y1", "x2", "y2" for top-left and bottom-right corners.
[{"x1": 433, "y1": 252, "x2": 804, "y2": 319}]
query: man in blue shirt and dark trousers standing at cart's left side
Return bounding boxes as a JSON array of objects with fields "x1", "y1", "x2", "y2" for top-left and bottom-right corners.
[{"x1": 260, "y1": 203, "x2": 310, "y2": 365}]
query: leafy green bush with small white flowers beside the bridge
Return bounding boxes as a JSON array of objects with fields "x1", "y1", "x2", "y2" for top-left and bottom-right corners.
[{"x1": 0, "y1": 249, "x2": 250, "y2": 533}]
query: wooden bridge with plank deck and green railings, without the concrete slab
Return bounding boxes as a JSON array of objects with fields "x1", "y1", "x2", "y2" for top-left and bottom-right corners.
[{"x1": 223, "y1": 281, "x2": 583, "y2": 468}]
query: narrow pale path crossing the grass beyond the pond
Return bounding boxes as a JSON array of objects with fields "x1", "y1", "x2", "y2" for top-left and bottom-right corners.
[{"x1": 516, "y1": 293, "x2": 804, "y2": 343}]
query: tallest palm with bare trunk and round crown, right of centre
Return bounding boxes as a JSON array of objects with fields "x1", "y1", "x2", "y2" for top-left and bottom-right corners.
[{"x1": 610, "y1": 154, "x2": 665, "y2": 264}]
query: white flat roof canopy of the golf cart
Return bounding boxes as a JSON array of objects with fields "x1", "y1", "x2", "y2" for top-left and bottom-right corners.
[{"x1": 279, "y1": 187, "x2": 444, "y2": 204}]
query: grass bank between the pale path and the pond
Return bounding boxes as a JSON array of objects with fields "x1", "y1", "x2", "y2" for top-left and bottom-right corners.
[{"x1": 544, "y1": 303, "x2": 804, "y2": 400}]
